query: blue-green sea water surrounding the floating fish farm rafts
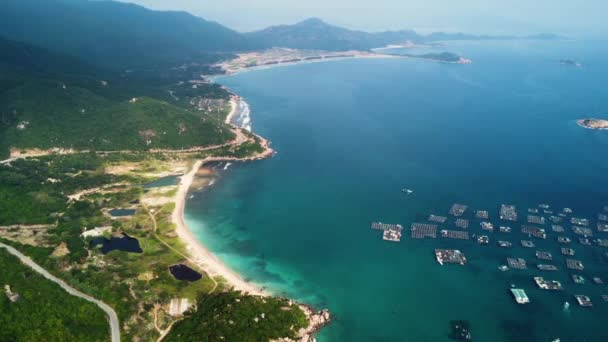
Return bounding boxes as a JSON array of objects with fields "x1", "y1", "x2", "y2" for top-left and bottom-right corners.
[{"x1": 186, "y1": 41, "x2": 608, "y2": 342}]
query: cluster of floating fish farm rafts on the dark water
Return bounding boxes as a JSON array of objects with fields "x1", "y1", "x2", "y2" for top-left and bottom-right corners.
[{"x1": 371, "y1": 203, "x2": 608, "y2": 307}]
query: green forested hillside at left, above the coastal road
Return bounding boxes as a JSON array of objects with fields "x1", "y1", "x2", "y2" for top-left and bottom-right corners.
[{"x1": 0, "y1": 39, "x2": 234, "y2": 157}]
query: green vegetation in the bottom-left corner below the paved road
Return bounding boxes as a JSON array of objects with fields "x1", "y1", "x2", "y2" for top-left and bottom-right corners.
[{"x1": 0, "y1": 248, "x2": 109, "y2": 341}]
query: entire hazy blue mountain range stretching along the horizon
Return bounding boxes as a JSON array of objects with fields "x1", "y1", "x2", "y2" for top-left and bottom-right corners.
[{"x1": 0, "y1": 0, "x2": 555, "y2": 70}]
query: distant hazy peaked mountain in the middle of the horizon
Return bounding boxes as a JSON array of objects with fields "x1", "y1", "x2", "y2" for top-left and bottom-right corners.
[{"x1": 245, "y1": 18, "x2": 420, "y2": 51}]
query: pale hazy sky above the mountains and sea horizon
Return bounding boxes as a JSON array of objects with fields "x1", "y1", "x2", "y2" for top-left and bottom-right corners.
[{"x1": 121, "y1": 0, "x2": 608, "y2": 35}]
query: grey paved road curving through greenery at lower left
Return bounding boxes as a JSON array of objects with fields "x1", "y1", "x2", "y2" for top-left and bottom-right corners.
[{"x1": 0, "y1": 242, "x2": 120, "y2": 342}]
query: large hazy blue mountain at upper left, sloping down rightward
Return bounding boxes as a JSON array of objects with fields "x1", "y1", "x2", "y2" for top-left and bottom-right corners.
[{"x1": 0, "y1": 0, "x2": 254, "y2": 69}]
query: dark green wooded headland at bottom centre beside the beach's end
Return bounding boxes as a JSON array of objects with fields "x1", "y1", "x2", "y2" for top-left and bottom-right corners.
[{"x1": 166, "y1": 292, "x2": 308, "y2": 342}]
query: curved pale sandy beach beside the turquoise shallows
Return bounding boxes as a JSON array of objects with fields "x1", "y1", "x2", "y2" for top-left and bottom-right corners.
[{"x1": 172, "y1": 160, "x2": 270, "y2": 296}]
